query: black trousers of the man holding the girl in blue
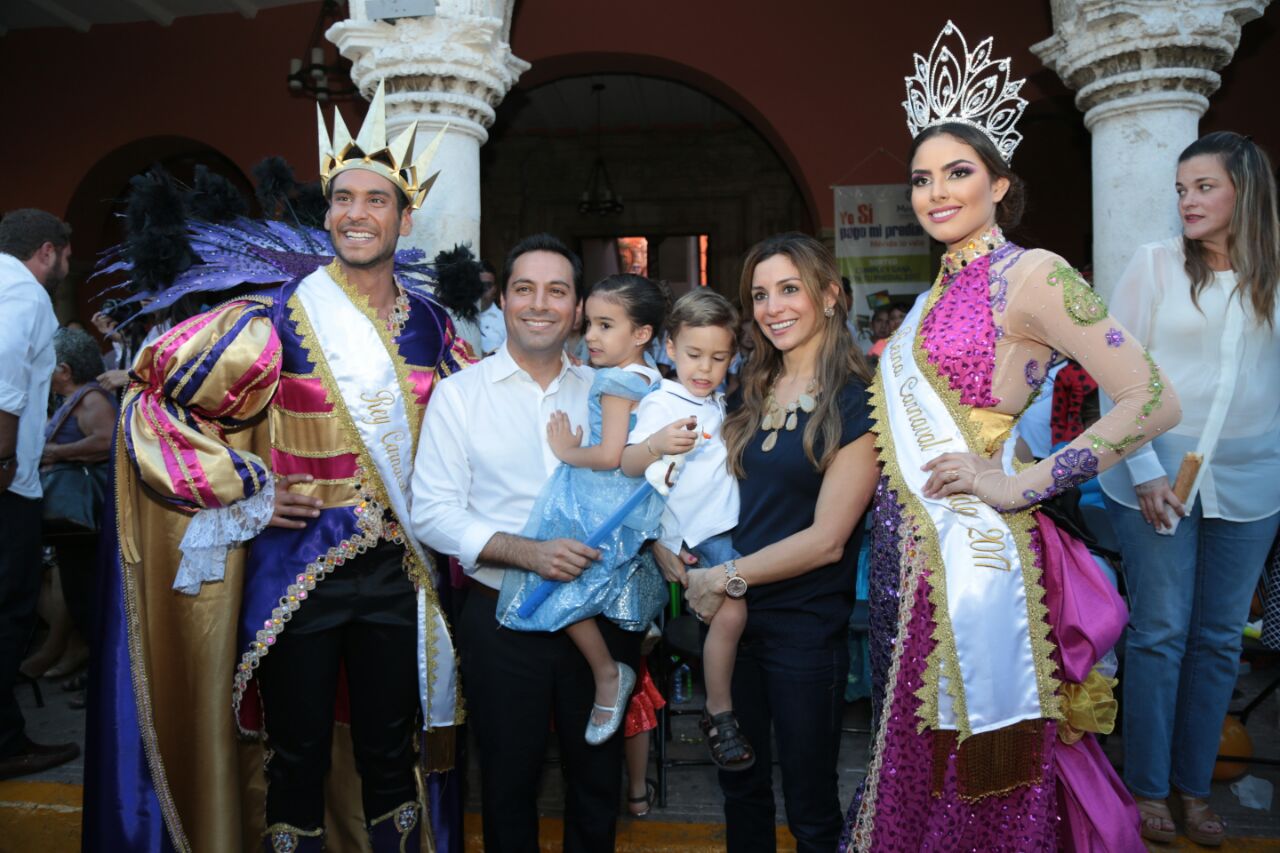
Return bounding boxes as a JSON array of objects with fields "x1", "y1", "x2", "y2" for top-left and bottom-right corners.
[{"x1": 458, "y1": 588, "x2": 641, "y2": 853}]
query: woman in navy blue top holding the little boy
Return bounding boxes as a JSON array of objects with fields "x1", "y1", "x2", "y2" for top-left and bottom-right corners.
[{"x1": 655, "y1": 234, "x2": 879, "y2": 853}]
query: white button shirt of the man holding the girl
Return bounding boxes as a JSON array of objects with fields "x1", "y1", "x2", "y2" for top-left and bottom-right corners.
[{"x1": 411, "y1": 345, "x2": 593, "y2": 589}]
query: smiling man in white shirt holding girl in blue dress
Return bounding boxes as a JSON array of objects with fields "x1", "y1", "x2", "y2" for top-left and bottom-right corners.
[{"x1": 412, "y1": 234, "x2": 640, "y2": 853}]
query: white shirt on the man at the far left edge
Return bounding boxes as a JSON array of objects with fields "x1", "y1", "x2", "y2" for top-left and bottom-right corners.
[{"x1": 0, "y1": 252, "x2": 58, "y2": 498}]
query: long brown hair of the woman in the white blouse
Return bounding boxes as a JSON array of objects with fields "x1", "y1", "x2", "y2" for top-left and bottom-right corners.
[{"x1": 1178, "y1": 131, "x2": 1280, "y2": 327}]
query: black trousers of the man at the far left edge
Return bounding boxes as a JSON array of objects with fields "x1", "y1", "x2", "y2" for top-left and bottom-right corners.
[{"x1": 0, "y1": 492, "x2": 42, "y2": 758}]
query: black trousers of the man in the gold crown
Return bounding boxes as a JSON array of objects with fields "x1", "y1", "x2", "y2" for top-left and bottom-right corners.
[{"x1": 257, "y1": 543, "x2": 419, "y2": 830}]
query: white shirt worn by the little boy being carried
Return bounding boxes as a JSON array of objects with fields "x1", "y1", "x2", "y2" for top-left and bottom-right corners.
[{"x1": 627, "y1": 379, "x2": 739, "y2": 553}]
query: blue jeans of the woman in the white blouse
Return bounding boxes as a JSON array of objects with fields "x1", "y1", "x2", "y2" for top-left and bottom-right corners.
[{"x1": 1107, "y1": 498, "x2": 1280, "y2": 798}]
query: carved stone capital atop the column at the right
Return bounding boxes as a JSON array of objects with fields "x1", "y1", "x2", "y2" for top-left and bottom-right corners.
[{"x1": 1032, "y1": 0, "x2": 1270, "y2": 117}]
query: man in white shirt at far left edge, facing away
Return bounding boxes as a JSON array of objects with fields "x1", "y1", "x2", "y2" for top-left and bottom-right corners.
[{"x1": 0, "y1": 209, "x2": 79, "y2": 779}]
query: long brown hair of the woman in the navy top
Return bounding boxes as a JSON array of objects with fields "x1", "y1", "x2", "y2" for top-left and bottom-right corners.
[{"x1": 723, "y1": 233, "x2": 872, "y2": 479}]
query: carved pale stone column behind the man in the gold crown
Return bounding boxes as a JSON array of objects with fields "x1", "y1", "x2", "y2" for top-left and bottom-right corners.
[{"x1": 325, "y1": 0, "x2": 529, "y2": 256}]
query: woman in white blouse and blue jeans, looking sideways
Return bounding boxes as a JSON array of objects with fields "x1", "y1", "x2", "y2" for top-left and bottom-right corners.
[{"x1": 1102, "y1": 132, "x2": 1280, "y2": 845}]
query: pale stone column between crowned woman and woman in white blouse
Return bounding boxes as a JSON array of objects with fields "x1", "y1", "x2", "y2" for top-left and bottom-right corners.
[{"x1": 1032, "y1": 0, "x2": 1271, "y2": 296}]
